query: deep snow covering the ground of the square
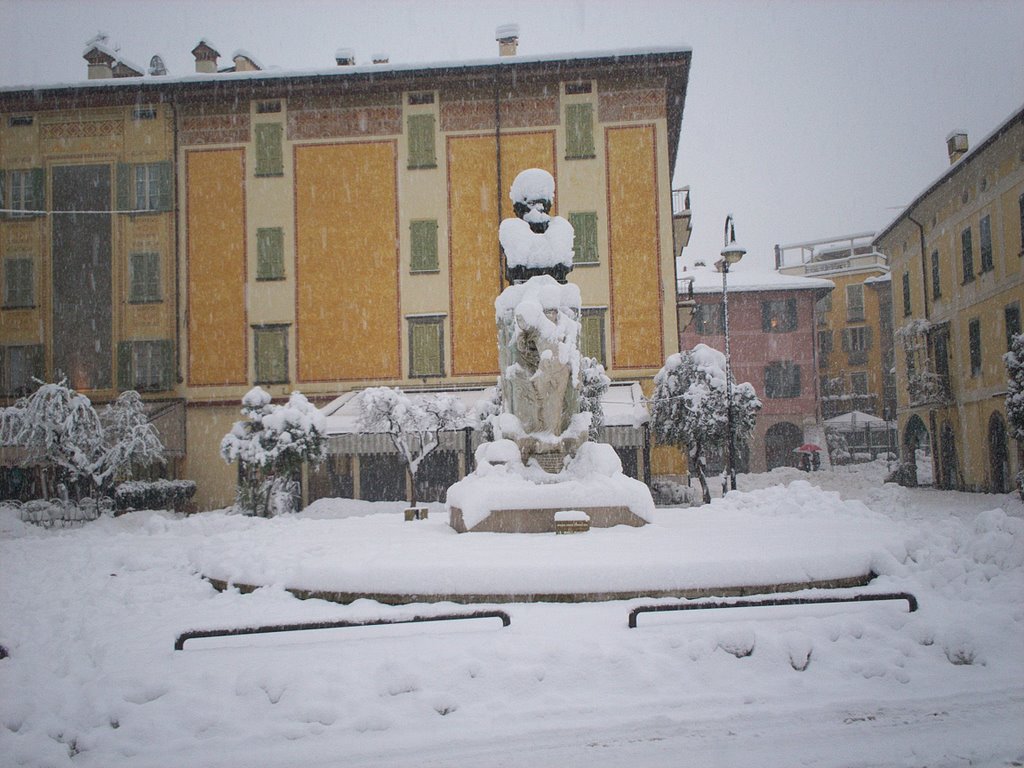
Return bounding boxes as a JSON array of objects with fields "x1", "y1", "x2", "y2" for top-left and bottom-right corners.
[{"x1": 0, "y1": 464, "x2": 1024, "y2": 768}]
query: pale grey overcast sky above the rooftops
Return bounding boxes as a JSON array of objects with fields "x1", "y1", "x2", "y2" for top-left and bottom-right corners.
[{"x1": 0, "y1": 0, "x2": 1024, "y2": 266}]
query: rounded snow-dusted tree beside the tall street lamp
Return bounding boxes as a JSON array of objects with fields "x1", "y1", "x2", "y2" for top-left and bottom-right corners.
[{"x1": 651, "y1": 344, "x2": 761, "y2": 504}]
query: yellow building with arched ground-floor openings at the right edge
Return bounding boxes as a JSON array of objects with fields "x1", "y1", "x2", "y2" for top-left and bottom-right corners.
[{"x1": 874, "y1": 110, "x2": 1024, "y2": 493}]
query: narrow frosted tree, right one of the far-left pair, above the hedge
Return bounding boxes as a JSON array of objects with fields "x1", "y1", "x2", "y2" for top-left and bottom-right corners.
[{"x1": 95, "y1": 389, "x2": 166, "y2": 488}]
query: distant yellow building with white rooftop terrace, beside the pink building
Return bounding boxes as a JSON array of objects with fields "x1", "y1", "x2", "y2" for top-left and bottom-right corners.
[{"x1": 775, "y1": 232, "x2": 896, "y2": 420}]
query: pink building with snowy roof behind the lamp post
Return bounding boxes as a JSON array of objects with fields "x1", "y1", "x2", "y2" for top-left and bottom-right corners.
[{"x1": 679, "y1": 264, "x2": 834, "y2": 472}]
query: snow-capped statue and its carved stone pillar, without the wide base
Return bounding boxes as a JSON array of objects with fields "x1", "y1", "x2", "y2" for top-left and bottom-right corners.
[{"x1": 495, "y1": 168, "x2": 590, "y2": 471}]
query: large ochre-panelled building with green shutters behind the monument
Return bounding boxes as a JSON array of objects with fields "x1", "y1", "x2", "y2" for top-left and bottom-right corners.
[{"x1": 0, "y1": 36, "x2": 690, "y2": 508}]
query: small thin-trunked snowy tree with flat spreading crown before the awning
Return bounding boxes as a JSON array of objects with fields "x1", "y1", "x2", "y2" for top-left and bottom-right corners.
[{"x1": 359, "y1": 387, "x2": 466, "y2": 507}]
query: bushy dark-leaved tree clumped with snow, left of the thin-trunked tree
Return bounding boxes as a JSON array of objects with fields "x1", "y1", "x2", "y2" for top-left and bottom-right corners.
[{"x1": 220, "y1": 387, "x2": 327, "y2": 517}]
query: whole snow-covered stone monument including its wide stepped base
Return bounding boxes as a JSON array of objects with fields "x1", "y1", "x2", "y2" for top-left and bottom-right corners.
[{"x1": 447, "y1": 168, "x2": 654, "y2": 532}]
